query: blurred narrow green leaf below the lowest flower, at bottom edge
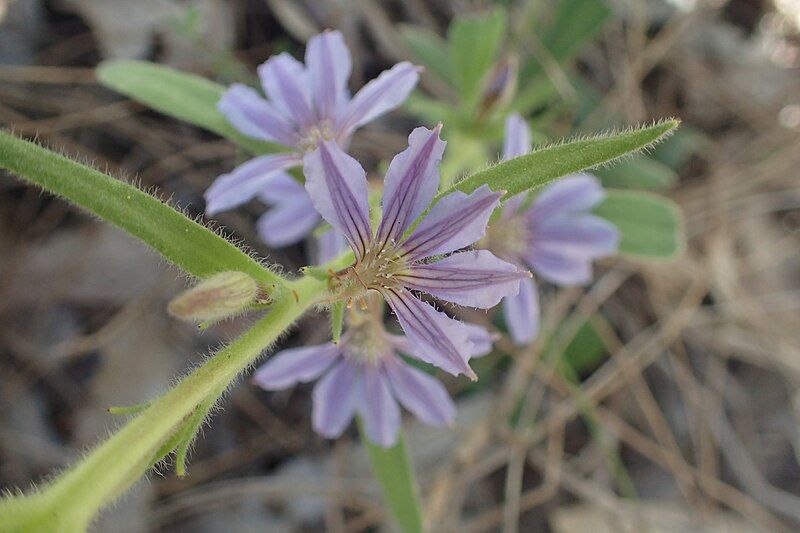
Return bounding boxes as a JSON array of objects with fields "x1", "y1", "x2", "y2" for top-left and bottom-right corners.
[{"x1": 358, "y1": 419, "x2": 422, "y2": 533}]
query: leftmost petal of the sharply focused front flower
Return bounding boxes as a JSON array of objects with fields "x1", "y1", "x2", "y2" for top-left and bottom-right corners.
[{"x1": 303, "y1": 141, "x2": 372, "y2": 258}]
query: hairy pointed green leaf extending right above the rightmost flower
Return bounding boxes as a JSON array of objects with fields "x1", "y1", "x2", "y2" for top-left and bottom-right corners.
[{"x1": 446, "y1": 120, "x2": 680, "y2": 199}]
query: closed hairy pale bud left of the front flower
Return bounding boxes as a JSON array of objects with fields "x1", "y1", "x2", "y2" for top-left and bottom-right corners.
[{"x1": 167, "y1": 271, "x2": 258, "y2": 322}]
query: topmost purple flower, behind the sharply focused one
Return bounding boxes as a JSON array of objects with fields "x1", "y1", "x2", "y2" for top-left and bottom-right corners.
[{"x1": 205, "y1": 31, "x2": 419, "y2": 251}]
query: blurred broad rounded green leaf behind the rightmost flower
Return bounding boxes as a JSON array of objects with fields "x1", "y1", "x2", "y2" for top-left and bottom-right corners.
[{"x1": 595, "y1": 191, "x2": 684, "y2": 259}]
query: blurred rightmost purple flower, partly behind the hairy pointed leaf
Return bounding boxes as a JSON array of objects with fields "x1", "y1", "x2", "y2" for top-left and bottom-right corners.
[{"x1": 484, "y1": 115, "x2": 620, "y2": 344}]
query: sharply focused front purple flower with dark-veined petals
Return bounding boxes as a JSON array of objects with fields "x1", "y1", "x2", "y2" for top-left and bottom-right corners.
[{"x1": 303, "y1": 126, "x2": 530, "y2": 379}]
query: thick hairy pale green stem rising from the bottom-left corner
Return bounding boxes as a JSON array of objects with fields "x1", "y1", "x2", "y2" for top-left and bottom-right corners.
[{"x1": 0, "y1": 277, "x2": 326, "y2": 531}]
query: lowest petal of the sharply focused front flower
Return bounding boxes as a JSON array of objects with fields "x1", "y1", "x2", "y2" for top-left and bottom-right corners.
[{"x1": 383, "y1": 289, "x2": 477, "y2": 380}]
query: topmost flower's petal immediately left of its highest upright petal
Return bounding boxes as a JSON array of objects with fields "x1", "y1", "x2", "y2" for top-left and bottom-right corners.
[{"x1": 258, "y1": 52, "x2": 315, "y2": 129}]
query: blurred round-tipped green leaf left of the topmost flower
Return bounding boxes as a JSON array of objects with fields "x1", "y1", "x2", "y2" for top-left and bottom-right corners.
[{"x1": 97, "y1": 59, "x2": 286, "y2": 154}]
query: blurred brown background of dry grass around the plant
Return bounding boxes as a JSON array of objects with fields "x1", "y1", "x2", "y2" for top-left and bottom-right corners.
[{"x1": 0, "y1": 0, "x2": 800, "y2": 533}]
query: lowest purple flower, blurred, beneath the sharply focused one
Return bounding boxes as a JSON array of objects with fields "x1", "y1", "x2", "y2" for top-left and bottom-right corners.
[{"x1": 253, "y1": 309, "x2": 491, "y2": 447}]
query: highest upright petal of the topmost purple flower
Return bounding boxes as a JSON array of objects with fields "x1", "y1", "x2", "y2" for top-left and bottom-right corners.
[{"x1": 306, "y1": 31, "x2": 352, "y2": 120}]
